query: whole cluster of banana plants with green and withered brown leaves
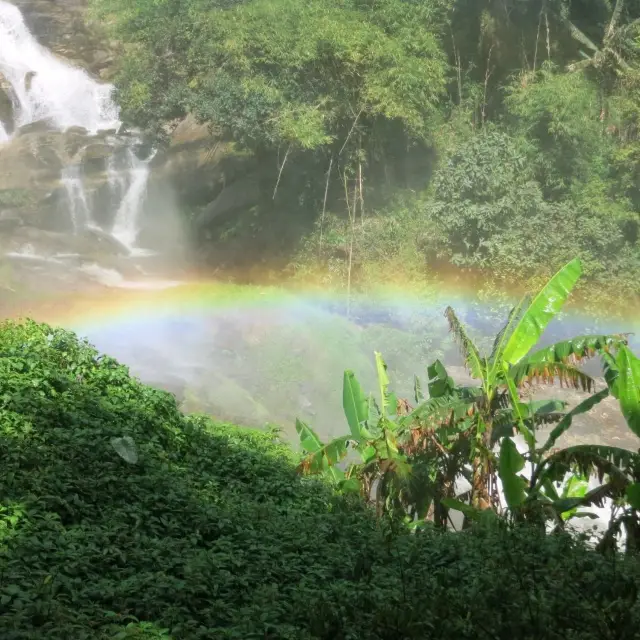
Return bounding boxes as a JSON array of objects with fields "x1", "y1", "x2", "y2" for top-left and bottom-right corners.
[{"x1": 297, "y1": 259, "x2": 640, "y2": 553}]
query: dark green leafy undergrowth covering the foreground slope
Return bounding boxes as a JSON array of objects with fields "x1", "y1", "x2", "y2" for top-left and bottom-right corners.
[{"x1": 0, "y1": 322, "x2": 640, "y2": 640}]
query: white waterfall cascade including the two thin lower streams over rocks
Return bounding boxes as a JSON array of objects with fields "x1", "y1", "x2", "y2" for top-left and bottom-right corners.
[{"x1": 0, "y1": 0, "x2": 153, "y2": 253}]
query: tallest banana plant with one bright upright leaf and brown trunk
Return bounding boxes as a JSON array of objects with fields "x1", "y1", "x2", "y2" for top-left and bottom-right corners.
[{"x1": 432, "y1": 259, "x2": 627, "y2": 510}]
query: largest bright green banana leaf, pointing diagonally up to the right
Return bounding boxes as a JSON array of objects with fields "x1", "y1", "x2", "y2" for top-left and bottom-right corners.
[{"x1": 501, "y1": 258, "x2": 582, "y2": 365}]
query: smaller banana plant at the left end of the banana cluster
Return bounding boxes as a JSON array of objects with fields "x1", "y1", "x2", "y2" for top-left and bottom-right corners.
[{"x1": 296, "y1": 352, "x2": 411, "y2": 514}]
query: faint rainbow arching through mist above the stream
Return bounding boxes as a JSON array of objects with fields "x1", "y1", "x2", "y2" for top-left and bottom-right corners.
[{"x1": 7, "y1": 280, "x2": 640, "y2": 349}]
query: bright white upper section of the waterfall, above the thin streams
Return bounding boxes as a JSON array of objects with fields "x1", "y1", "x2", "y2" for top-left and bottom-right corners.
[{"x1": 0, "y1": 0, "x2": 119, "y2": 132}]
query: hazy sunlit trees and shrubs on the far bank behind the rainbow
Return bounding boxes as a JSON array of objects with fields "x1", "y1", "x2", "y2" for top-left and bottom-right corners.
[{"x1": 94, "y1": 0, "x2": 640, "y2": 296}]
